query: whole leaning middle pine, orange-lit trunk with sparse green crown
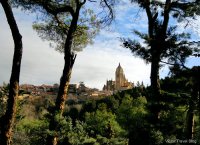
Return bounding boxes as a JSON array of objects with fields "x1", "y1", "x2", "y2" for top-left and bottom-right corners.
[{"x1": 13, "y1": 0, "x2": 114, "y2": 145}]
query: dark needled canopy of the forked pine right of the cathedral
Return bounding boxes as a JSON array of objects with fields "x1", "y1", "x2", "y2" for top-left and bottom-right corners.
[{"x1": 122, "y1": 0, "x2": 200, "y2": 65}]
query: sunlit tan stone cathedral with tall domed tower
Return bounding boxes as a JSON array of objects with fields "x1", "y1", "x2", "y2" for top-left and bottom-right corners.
[{"x1": 103, "y1": 63, "x2": 134, "y2": 91}]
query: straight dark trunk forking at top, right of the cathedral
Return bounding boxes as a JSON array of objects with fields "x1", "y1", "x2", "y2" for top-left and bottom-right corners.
[{"x1": 145, "y1": 0, "x2": 171, "y2": 124}]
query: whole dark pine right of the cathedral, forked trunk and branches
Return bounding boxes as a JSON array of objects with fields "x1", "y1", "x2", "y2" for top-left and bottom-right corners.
[{"x1": 122, "y1": 0, "x2": 200, "y2": 125}]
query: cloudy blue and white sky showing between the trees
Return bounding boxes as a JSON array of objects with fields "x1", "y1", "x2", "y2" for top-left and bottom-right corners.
[{"x1": 0, "y1": 1, "x2": 200, "y2": 89}]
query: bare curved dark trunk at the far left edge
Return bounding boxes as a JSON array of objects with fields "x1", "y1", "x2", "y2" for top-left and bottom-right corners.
[{"x1": 0, "y1": 0, "x2": 22, "y2": 145}]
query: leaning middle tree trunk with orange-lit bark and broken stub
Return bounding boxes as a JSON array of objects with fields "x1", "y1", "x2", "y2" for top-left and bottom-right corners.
[{"x1": 46, "y1": 8, "x2": 80, "y2": 145}]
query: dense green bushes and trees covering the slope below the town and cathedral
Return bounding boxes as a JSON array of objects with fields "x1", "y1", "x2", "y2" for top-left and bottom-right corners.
[{"x1": 0, "y1": 67, "x2": 200, "y2": 145}]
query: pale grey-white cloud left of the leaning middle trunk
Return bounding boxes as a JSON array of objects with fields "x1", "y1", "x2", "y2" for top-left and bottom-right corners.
[{"x1": 0, "y1": 9, "x2": 63, "y2": 84}]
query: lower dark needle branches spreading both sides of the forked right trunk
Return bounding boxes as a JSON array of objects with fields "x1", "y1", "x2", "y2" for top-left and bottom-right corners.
[{"x1": 122, "y1": 26, "x2": 200, "y2": 65}]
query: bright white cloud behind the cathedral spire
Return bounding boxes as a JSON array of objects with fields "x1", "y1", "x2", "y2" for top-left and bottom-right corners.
[{"x1": 72, "y1": 36, "x2": 150, "y2": 89}]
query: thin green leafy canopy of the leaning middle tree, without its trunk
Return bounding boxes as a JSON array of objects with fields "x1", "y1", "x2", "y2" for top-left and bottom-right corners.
[{"x1": 13, "y1": 0, "x2": 116, "y2": 52}]
